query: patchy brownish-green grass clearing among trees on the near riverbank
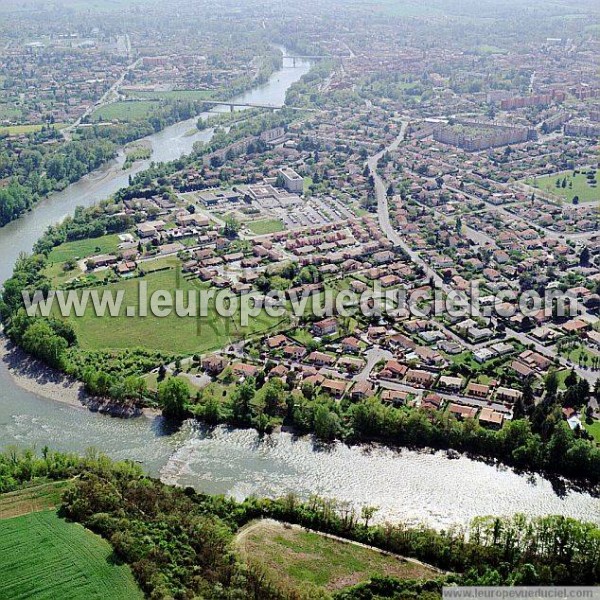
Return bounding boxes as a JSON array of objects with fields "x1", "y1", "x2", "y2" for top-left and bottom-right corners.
[{"x1": 236, "y1": 521, "x2": 437, "y2": 592}]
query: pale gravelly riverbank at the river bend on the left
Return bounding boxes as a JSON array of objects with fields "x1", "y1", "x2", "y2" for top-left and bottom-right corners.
[{"x1": 0, "y1": 333, "x2": 160, "y2": 418}]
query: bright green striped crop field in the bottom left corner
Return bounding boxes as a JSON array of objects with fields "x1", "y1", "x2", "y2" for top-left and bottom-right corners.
[{"x1": 0, "y1": 511, "x2": 143, "y2": 600}]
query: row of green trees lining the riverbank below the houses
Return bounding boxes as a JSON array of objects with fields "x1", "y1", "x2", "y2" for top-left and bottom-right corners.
[{"x1": 158, "y1": 360, "x2": 600, "y2": 486}]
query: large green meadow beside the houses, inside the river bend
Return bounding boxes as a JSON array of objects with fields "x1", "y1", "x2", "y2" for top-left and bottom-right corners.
[{"x1": 55, "y1": 263, "x2": 288, "y2": 354}]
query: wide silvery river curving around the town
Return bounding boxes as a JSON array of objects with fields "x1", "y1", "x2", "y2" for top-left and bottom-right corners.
[{"x1": 0, "y1": 52, "x2": 600, "y2": 528}]
